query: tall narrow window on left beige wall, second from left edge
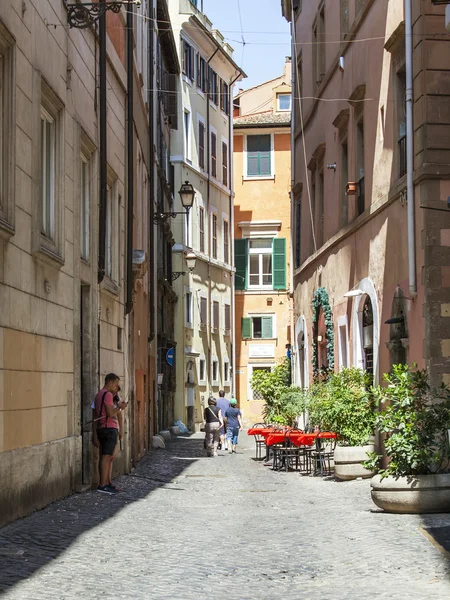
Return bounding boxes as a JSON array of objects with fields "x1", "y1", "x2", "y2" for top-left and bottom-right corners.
[{"x1": 41, "y1": 106, "x2": 56, "y2": 241}]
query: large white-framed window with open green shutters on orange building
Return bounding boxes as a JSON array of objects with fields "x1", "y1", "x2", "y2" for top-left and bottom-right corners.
[{"x1": 234, "y1": 238, "x2": 286, "y2": 290}]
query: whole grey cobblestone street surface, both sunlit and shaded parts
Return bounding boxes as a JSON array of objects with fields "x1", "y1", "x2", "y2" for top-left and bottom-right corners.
[{"x1": 0, "y1": 435, "x2": 450, "y2": 600}]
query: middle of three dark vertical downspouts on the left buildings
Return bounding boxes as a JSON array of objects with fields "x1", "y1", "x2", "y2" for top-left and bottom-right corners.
[{"x1": 125, "y1": 4, "x2": 134, "y2": 315}]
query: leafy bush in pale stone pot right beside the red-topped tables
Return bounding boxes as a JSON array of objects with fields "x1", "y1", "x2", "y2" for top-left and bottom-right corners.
[{"x1": 308, "y1": 368, "x2": 375, "y2": 480}]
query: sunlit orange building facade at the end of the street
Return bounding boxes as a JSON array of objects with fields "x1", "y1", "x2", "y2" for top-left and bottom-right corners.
[{"x1": 234, "y1": 59, "x2": 292, "y2": 424}]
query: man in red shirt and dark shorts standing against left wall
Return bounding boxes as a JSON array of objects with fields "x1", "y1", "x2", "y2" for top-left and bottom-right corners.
[{"x1": 93, "y1": 373, "x2": 127, "y2": 494}]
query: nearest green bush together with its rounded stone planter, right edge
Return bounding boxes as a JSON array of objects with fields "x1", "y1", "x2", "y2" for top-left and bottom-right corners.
[{"x1": 366, "y1": 365, "x2": 450, "y2": 513}]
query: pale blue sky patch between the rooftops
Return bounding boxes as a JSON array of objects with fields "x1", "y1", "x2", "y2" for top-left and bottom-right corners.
[{"x1": 202, "y1": 0, "x2": 291, "y2": 89}]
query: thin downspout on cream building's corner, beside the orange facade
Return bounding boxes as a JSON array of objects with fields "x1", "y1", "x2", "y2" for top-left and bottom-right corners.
[{"x1": 228, "y1": 73, "x2": 240, "y2": 397}]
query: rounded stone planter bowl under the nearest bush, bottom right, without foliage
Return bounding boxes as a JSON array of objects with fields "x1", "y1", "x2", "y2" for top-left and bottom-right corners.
[{"x1": 371, "y1": 473, "x2": 450, "y2": 513}]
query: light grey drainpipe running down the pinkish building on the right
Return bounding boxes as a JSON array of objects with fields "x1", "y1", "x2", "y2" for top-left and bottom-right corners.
[{"x1": 405, "y1": 0, "x2": 417, "y2": 298}]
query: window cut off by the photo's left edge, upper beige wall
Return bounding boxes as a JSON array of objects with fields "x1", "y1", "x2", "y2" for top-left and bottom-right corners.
[{"x1": 0, "y1": 22, "x2": 16, "y2": 234}]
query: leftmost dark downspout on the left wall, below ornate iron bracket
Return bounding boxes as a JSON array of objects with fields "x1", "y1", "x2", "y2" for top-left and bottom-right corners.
[{"x1": 98, "y1": 0, "x2": 107, "y2": 283}]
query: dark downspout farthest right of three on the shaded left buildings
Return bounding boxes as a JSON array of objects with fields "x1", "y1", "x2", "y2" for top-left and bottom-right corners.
[{"x1": 148, "y1": 0, "x2": 156, "y2": 342}]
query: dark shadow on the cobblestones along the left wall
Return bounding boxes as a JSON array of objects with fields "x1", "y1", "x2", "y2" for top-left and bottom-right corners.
[{"x1": 0, "y1": 437, "x2": 204, "y2": 595}]
